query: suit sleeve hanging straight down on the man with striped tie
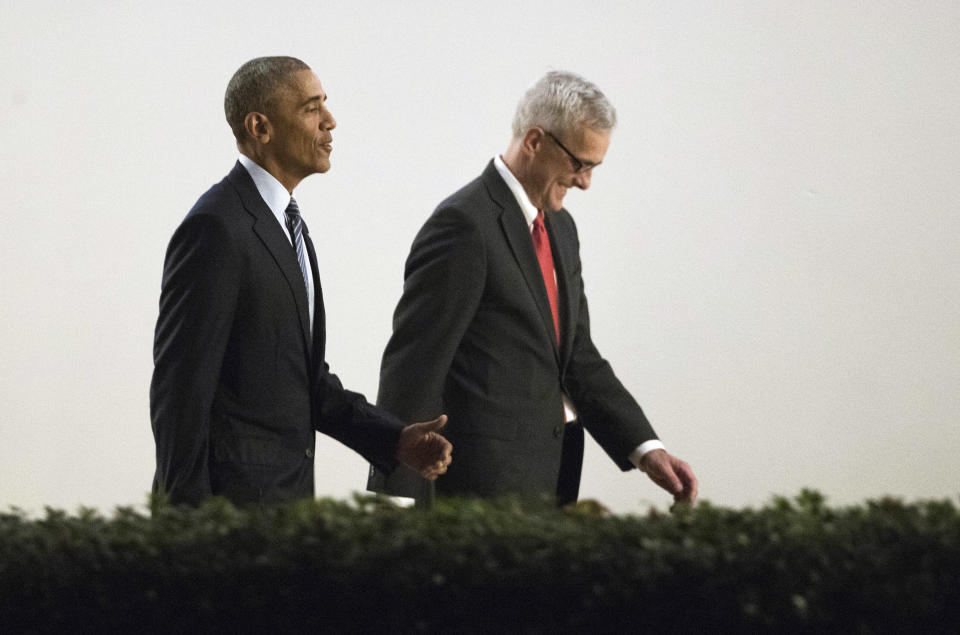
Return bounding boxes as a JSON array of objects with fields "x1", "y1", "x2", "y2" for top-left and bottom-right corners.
[{"x1": 150, "y1": 214, "x2": 240, "y2": 504}]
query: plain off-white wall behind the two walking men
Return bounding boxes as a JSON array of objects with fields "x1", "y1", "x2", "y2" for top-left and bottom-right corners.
[{"x1": 0, "y1": 0, "x2": 960, "y2": 512}]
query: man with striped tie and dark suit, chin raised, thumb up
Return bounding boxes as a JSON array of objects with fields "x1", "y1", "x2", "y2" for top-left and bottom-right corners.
[{"x1": 150, "y1": 57, "x2": 450, "y2": 505}]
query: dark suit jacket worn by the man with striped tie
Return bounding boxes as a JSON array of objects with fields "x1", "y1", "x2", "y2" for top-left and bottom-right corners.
[{"x1": 150, "y1": 163, "x2": 403, "y2": 504}]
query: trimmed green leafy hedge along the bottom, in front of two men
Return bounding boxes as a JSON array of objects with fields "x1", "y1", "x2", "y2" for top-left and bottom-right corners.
[{"x1": 0, "y1": 491, "x2": 960, "y2": 633}]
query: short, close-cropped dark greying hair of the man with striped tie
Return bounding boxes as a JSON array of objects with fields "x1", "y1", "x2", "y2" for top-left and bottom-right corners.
[{"x1": 223, "y1": 56, "x2": 310, "y2": 141}]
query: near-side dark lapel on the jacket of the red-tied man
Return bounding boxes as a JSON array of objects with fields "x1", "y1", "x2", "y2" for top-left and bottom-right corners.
[{"x1": 483, "y1": 161, "x2": 560, "y2": 363}]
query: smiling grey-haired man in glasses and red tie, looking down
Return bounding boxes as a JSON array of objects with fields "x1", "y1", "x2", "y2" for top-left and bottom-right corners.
[{"x1": 369, "y1": 72, "x2": 697, "y2": 504}]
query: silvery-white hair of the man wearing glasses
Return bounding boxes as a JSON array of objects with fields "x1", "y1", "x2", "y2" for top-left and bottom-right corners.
[{"x1": 513, "y1": 71, "x2": 617, "y2": 139}]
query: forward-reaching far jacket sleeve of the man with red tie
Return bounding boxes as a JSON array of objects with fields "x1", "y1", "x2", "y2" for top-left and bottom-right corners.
[{"x1": 564, "y1": 217, "x2": 657, "y2": 471}]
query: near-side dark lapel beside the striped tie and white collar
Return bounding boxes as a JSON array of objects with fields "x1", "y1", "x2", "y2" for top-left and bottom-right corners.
[{"x1": 227, "y1": 161, "x2": 310, "y2": 358}]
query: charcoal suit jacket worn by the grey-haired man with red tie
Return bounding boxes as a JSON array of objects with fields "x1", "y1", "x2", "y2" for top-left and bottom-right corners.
[{"x1": 369, "y1": 161, "x2": 656, "y2": 498}]
